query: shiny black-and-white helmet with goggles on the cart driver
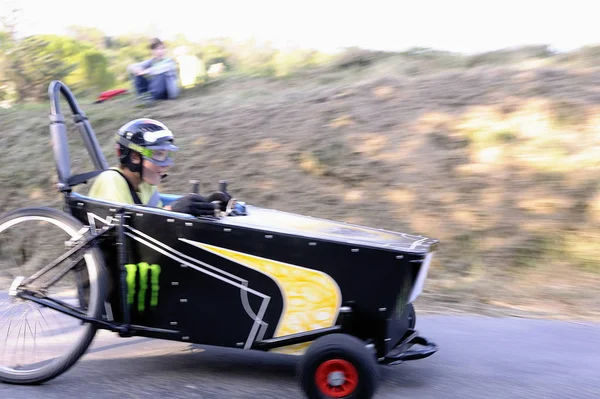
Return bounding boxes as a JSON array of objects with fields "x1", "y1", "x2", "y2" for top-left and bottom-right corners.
[{"x1": 116, "y1": 118, "x2": 179, "y2": 173}]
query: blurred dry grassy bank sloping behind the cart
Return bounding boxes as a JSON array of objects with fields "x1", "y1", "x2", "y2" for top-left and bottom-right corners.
[{"x1": 0, "y1": 57, "x2": 600, "y2": 318}]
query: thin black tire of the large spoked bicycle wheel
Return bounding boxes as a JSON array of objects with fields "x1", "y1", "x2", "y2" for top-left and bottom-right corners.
[{"x1": 0, "y1": 207, "x2": 109, "y2": 385}]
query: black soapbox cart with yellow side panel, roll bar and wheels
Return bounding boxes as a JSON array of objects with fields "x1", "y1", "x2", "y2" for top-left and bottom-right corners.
[{"x1": 0, "y1": 81, "x2": 437, "y2": 398}]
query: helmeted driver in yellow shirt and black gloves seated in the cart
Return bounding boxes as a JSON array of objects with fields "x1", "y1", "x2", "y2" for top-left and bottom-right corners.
[{"x1": 88, "y1": 118, "x2": 231, "y2": 216}]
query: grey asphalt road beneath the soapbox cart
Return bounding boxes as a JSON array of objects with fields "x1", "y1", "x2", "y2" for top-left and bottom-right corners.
[{"x1": 0, "y1": 316, "x2": 600, "y2": 399}]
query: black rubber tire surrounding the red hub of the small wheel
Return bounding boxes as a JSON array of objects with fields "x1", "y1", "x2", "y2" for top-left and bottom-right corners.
[{"x1": 296, "y1": 334, "x2": 380, "y2": 399}]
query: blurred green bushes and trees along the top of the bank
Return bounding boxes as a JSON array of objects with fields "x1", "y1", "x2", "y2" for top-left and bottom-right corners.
[{"x1": 0, "y1": 6, "x2": 600, "y2": 105}]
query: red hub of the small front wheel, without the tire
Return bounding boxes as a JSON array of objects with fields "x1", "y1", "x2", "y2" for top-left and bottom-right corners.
[{"x1": 315, "y1": 359, "x2": 358, "y2": 398}]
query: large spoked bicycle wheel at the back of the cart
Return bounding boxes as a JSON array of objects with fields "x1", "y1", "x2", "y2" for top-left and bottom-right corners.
[{"x1": 0, "y1": 207, "x2": 108, "y2": 384}]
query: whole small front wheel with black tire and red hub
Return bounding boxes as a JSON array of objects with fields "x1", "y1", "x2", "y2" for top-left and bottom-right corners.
[{"x1": 297, "y1": 334, "x2": 379, "y2": 399}]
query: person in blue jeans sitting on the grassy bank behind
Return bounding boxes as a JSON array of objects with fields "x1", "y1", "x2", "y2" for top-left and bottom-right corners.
[{"x1": 127, "y1": 38, "x2": 181, "y2": 103}]
